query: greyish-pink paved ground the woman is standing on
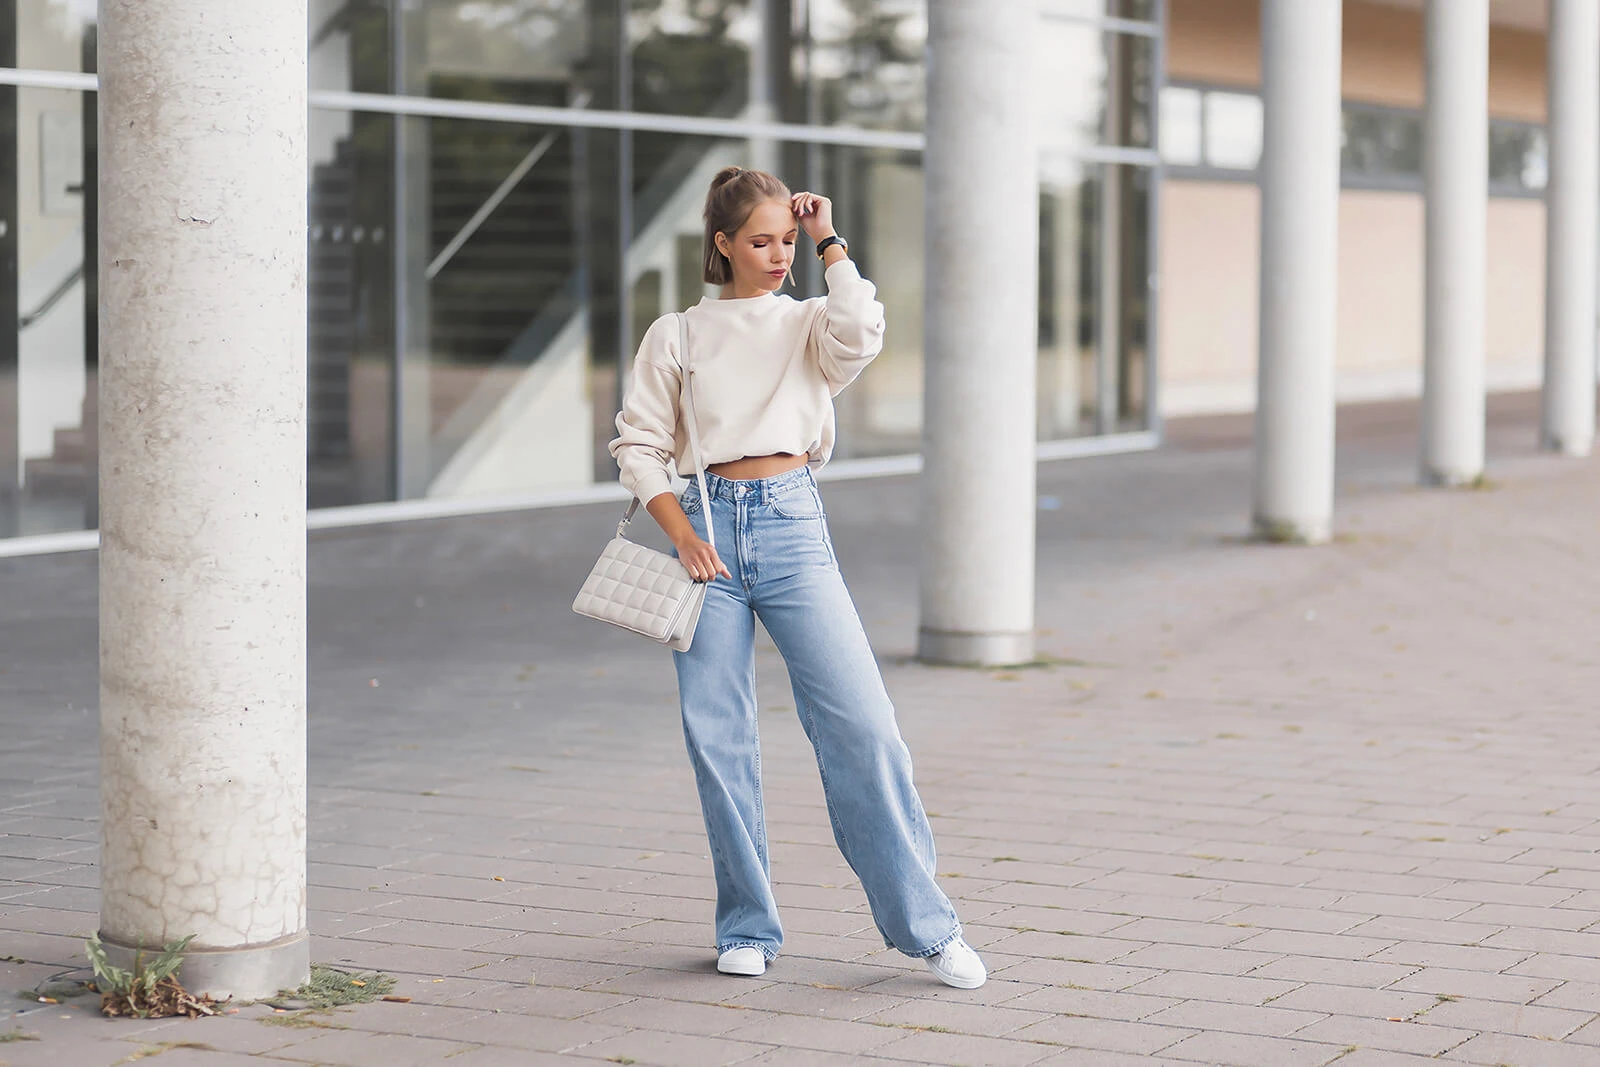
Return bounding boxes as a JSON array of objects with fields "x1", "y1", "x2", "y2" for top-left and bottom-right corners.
[{"x1": 0, "y1": 398, "x2": 1600, "y2": 1067}]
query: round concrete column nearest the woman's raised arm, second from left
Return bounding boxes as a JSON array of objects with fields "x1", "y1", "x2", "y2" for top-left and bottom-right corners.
[{"x1": 917, "y1": 0, "x2": 1038, "y2": 664}]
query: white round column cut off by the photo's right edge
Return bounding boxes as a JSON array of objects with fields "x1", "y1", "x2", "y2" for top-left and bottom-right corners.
[{"x1": 1541, "y1": 0, "x2": 1600, "y2": 456}]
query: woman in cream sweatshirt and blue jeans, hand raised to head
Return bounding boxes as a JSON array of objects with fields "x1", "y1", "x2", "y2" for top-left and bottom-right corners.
[{"x1": 611, "y1": 166, "x2": 987, "y2": 989}]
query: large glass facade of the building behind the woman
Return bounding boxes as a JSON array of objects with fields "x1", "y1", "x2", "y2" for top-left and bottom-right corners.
[{"x1": 0, "y1": 0, "x2": 1166, "y2": 536}]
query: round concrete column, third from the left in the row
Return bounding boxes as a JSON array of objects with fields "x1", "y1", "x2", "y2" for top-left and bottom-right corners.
[{"x1": 1253, "y1": 0, "x2": 1341, "y2": 544}]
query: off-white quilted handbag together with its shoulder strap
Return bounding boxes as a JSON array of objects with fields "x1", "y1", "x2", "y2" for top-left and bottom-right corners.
[{"x1": 573, "y1": 314, "x2": 717, "y2": 653}]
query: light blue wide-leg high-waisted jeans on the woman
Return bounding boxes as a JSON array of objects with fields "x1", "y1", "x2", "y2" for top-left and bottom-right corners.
[{"x1": 674, "y1": 467, "x2": 960, "y2": 958}]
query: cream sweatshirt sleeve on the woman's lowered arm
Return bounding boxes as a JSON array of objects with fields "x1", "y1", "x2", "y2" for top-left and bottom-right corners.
[{"x1": 611, "y1": 315, "x2": 682, "y2": 504}]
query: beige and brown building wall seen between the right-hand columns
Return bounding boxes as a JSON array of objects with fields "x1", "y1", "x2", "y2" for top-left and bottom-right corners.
[{"x1": 1157, "y1": 0, "x2": 1544, "y2": 416}]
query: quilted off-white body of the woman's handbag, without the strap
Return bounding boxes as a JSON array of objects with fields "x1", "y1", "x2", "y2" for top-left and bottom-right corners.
[{"x1": 573, "y1": 536, "x2": 706, "y2": 653}]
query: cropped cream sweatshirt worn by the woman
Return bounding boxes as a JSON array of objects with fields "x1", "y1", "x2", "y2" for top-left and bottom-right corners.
[{"x1": 611, "y1": 259, "x2": 883, "y2": 502}]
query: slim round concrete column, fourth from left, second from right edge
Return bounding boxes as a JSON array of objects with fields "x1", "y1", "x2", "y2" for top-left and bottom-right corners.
[{"x1": 1422, "y1": 0, "x2": 1490, "y2": 485}]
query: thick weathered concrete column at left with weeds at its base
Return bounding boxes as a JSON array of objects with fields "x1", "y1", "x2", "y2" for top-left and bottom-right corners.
[{"x1": 99, "y1": 0, "x2": 309, "y2": 997}]
